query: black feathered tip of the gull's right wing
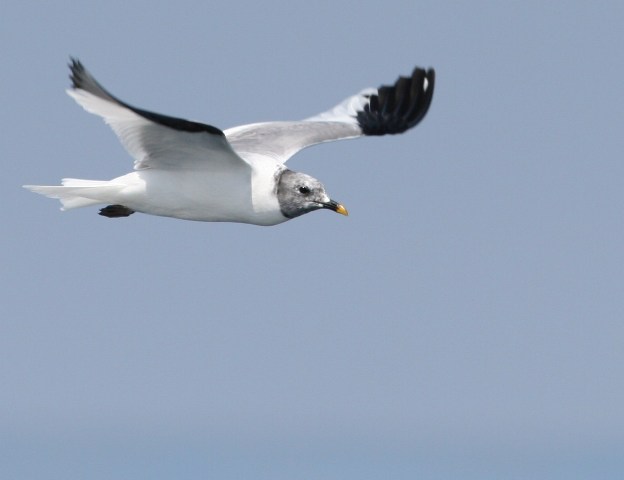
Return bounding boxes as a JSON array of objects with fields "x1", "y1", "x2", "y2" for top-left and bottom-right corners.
[{"x1": 357, "y1": 67, "x2": 435, "y2": 135}]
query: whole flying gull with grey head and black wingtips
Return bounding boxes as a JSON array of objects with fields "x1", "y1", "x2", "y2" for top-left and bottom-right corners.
[{"x1": 24, "y1": 58, "x2": 435, "y2": 226}]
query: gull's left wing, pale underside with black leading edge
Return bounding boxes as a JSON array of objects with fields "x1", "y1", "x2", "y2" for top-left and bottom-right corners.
[{"x1": 67, "y1": 59, "x2": 249, "y2": 170}]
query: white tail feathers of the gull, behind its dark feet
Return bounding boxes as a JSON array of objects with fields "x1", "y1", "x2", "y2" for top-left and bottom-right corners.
[{"x1": 24, "y1": 178, "x2": 124, "y2": 210}]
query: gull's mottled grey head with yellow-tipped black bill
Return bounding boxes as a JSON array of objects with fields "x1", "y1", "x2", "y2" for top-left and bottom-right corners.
[{"x1": 277, "y1": 169, "x2": 349, "y2": 218}]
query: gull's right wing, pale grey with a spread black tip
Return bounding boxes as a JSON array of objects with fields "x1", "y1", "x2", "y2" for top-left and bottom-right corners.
[{"x1": 224, "y1": 67, "x2": 435, "y2": 163}]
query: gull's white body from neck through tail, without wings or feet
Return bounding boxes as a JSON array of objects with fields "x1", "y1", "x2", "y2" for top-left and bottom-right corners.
[{"x1": 30, "y1": 160, "x2": 288, "y2": 225}]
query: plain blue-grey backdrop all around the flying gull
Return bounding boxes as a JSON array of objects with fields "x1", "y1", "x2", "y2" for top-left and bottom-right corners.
[{"x1": 0, "y1": 0, "x2": 624, "y2": 480}]
